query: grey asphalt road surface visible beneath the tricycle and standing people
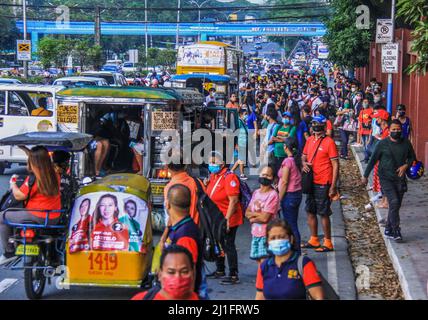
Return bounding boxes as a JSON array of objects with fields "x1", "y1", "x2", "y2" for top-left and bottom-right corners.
[{"x1": 0, "y1": 167, "x2": 355, "y2": 300}]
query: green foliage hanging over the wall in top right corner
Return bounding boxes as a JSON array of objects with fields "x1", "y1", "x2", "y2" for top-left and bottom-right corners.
[{"x1": 397, "y1": 0, "x2": 428, "y2": 75}]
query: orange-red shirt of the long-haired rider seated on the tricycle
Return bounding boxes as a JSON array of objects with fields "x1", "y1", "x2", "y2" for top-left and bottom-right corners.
[{"x1": 19, "y1": 176, "x2": 61, "y2": 219}]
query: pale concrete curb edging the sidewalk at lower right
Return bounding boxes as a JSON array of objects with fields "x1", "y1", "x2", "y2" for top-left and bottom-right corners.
[{"x1": 351, "y1": 146, "x2": 427, "y2": 300}]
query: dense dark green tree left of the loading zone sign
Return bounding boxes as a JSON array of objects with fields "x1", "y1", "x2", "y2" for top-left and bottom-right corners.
[{"x1": 324, "y1": 0, "x2": 374, "y2": 69}]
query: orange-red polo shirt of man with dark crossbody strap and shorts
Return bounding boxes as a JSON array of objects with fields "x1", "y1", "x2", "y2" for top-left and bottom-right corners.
[{"x1": 303, "y1": 136, "x2": 339, "y2": 185}]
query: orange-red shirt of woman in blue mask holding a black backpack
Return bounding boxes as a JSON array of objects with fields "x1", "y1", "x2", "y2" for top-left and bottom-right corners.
[{"x1": 207, "y1": 168, "x2": 243, "y2": 228}]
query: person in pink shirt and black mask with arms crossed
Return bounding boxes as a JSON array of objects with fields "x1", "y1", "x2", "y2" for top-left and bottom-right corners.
[{"x1": 245, "y1": 167, "x2": 279, "y2": 264}]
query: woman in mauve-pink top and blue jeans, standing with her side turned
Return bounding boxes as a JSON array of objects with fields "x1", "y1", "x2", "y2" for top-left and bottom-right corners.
[{"x1": 278, "y1": 138, "x2": 302, "y2": 252}]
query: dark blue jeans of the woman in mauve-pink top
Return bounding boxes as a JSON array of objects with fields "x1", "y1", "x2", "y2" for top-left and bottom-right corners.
[{"x1": 281, "y1": 190, "x2": 302, "y2": 252}]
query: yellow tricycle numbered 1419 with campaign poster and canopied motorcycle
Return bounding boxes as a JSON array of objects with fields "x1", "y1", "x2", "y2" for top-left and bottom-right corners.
[{"x1": 0, "y1": 132, "x2": 153, "y2": 299}]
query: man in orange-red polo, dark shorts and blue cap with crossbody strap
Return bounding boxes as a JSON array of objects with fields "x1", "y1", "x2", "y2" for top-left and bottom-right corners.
[{"x1": 302, "y1": 116, "x2": 339, "y2": 252}]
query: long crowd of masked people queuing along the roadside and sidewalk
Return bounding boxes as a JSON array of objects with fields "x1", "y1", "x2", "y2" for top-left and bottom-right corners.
[{"x1": 131, "y1": 63, "x2": 415, "y2": 300}]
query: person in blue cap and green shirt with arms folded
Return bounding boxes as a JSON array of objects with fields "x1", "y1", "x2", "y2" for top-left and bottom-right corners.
[{"x1": 272, "y1": 111, "x2": 296, "y2": 173}]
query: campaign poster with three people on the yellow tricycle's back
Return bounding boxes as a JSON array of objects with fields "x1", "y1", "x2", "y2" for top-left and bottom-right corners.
[{"x1": 69, "y1": 192, "x2": 149, "y2": 253}]
